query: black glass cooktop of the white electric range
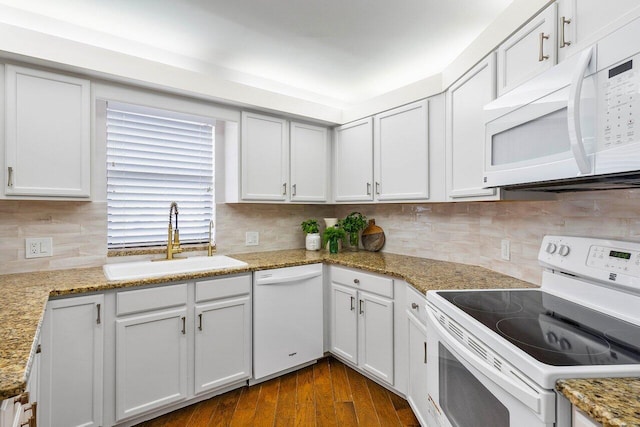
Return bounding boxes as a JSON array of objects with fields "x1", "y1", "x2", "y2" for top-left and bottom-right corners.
[{"x1": 438, "y1": 290, "x2": 640, "y2": 366}]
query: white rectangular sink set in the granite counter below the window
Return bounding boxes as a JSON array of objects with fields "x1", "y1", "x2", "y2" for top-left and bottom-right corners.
[{"x1": 102, "y1": 255, "x2": 247, "y2": 280}]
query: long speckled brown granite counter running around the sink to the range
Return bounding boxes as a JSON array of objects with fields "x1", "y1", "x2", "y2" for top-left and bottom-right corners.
[{"x1": 0, "y1": 249, "x2": 533, "y2": 400}]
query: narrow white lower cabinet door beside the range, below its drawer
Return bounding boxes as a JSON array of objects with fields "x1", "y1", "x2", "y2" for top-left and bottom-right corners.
[{"x1": 407, "y1": 311, "x2": 428, "y2": 425}]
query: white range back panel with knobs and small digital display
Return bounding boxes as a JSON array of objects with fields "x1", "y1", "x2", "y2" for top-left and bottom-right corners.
[{"x1": 538, "y1": 236, "x2": 640, "y2": 289}]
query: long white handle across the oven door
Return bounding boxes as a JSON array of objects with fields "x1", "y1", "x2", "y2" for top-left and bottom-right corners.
[{"x1": 427, "y1": 307, "x2": 542, "y2": 414}]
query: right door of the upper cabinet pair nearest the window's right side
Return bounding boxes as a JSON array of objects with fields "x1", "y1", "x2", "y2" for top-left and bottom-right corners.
[{"x1": 291, "y1": 123, "x2": 329, "y2": 202}]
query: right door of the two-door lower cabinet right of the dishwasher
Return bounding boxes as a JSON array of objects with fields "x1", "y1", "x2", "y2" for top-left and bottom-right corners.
[{"x1": 357, "y1": 292, "x2": 393, "y2": 385}]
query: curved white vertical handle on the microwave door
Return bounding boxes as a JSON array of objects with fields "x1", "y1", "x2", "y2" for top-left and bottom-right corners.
[{"x1": 567, "y1": 48, "x2": 593, "y2": 175}]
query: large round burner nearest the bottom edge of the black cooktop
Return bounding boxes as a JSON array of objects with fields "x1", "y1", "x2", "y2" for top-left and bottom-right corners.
[{"x1": 496, "y1": 314, "x2": 611, "y2": 357}]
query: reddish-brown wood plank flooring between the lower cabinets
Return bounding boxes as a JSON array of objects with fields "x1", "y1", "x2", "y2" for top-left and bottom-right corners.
[{"x1": 136, "y1": 357, "x2": 420, "y2": 427}]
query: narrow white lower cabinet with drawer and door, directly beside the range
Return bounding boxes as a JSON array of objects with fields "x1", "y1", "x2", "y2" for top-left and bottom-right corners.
[{"x1": 405, "y1": 287, "x2": 428, "y2": 426}]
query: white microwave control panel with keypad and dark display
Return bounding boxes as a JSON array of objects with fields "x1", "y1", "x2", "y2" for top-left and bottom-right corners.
[{"x1": 598, "y1": 55, "x2": 640, "y2": 150}]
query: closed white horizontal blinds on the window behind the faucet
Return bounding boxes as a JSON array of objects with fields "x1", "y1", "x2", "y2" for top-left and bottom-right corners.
[{"x1": 107, "y1": 102, "x2": 215, "y2": 248}]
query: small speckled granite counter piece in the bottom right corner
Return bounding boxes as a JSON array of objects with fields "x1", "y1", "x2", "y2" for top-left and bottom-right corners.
[{"x1": 556, "y1": 378, "x2": 640, "y2": 427}]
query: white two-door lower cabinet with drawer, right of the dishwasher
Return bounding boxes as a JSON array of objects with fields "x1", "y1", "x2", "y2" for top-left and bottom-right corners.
[{"x1": 330, "y1": 267, "x2": 394, "y2": 385}]
